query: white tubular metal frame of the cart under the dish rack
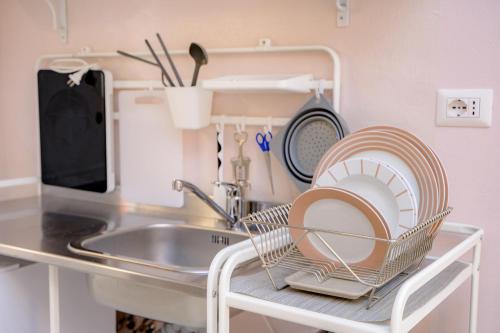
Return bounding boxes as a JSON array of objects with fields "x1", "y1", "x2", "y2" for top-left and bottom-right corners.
[{"x1": 213, "y1": 222, "x2": 484, "y2": 333}]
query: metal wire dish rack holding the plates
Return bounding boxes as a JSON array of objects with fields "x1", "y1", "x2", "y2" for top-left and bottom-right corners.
[{"x1": 241, "y1": 204, "x2": 452, "y2": 308}]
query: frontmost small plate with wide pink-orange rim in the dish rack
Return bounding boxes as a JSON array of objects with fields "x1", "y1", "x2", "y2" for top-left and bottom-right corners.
[{"x1": 288, "y1": 187, "x2": 390, "y2": 269}]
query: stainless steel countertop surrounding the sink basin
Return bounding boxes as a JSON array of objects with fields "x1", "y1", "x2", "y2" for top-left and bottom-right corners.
[{"x1": 0, "y1": 194, "x2": 236, "y2": 289}]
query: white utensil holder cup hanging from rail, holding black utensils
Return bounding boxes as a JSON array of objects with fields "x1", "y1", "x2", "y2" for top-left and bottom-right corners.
[{"x1": 165, "y1": 87, "x2": 214, "y2": 129}]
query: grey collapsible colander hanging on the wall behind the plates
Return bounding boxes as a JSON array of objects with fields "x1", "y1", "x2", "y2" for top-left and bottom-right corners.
[{"x1": 271, "y1": 94, "x2": 348, "y2": 191}]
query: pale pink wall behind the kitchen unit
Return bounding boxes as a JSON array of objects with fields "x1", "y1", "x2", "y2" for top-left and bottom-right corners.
[{"x1": 0, "y1": 0, "x2": 500, "y2": 332}]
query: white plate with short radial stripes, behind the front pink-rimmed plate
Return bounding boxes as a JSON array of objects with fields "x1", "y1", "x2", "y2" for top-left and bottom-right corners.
[{"x1": 314, "y1": 158, "x2": 418, "y2": 238}]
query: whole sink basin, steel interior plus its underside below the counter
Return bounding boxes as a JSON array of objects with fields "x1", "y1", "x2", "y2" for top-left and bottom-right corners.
[{"x1": 68, "y1": 224, "x2": 247, "y2": 328}]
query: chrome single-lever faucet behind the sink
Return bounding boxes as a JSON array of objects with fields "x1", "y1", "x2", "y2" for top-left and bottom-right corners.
[{"x1": 172, "y1": 179, "x2": 243, "y2": 229}]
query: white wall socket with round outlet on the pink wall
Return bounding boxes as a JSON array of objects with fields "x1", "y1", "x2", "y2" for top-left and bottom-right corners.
[{"x1": 436, "y1": 89, "x2": 493, "y2": 127}]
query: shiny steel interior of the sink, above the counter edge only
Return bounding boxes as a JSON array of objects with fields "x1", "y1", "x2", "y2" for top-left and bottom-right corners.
[{"x1": 69, "y1": 224, "x2": 247, "y2": 274}]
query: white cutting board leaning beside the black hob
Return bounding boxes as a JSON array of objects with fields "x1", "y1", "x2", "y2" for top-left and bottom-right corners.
[{"x1": 118, "y1": 91, "x2": 184, "y2": 207}]
